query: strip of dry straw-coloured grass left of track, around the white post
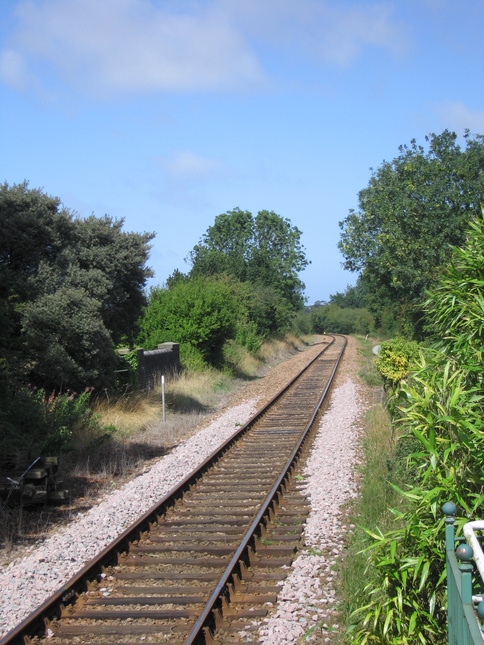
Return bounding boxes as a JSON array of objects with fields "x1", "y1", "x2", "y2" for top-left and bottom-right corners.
[{"x1": 68, "y1": 336, "x2": 318, "y2": 478}]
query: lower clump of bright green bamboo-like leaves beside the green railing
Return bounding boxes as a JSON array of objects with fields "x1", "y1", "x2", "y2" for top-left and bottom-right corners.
[{"x1": 351, "y1": 350, "x2": 484, "y2": 645}]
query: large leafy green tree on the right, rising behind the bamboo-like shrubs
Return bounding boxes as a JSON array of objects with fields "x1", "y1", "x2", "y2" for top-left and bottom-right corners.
[{"x1": 338, "y1": 130, "x2": 484, "y2": 328}]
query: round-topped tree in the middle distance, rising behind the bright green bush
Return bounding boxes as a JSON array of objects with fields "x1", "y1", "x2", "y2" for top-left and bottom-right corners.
[{"x1": 188, "y1": 208, "x2": 308, "y2": 311}]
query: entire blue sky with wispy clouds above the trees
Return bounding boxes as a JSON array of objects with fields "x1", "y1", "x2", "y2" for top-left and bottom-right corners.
[{"x1": 0, "y1": 0, "x2": 484, "y2": 303}]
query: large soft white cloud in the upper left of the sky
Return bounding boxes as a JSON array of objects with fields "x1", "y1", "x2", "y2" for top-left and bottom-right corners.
[{"x1": 4, "y1": 0, "x2": 263, "y2": 96}]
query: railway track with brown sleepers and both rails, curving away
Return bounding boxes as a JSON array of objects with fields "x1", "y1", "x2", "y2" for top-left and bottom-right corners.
[{"x1": 0, "y1": 336, "x2": 346, "y2": 645}]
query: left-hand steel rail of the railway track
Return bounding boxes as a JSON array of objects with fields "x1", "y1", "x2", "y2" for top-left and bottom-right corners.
[{"x1": 0, "y1": 336, "x2": 336, "y2": 645}]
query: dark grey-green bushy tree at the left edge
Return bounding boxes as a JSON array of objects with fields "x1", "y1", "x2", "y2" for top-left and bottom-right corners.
[{"x1": 0, "y1": 183, "x2": 153, "y2": 389}]
